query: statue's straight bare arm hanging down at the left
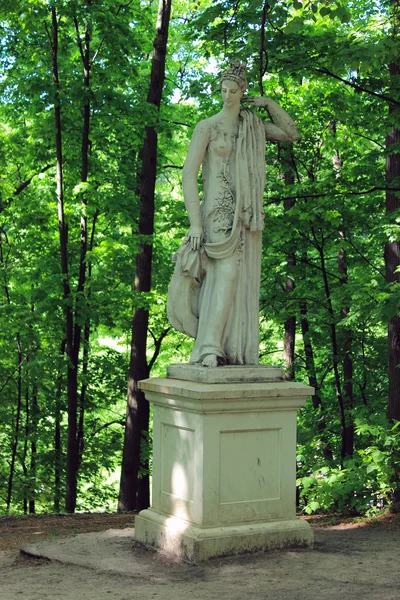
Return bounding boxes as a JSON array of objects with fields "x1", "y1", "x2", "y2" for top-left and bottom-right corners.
[{"x1": 182, "y1": 121, "x2": 210, "y2": 250}]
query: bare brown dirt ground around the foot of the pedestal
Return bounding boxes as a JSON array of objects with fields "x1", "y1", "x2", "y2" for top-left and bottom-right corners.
[{"x1": 0, "y1": 515, "x2": 400, "y2": 600}]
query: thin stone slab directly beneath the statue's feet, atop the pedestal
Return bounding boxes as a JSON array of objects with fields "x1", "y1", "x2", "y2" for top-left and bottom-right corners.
[{"x1": 167, "y1": 364, "x2": 284, "y2": 383}]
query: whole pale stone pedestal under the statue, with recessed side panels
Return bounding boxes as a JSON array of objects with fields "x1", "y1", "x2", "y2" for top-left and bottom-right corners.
[{"x1": 136, "y1": 365, "x2": 314, "y2": 562}]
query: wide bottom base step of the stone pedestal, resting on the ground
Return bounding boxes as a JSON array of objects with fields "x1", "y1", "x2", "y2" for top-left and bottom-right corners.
[{"x1": 135, "y1": 509, "x2": 314, "y2": 563}]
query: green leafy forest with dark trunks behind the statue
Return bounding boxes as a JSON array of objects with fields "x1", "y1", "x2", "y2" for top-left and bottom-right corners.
[{"x1": 0, "y1": 0, "x2": 400, "y2": 514}]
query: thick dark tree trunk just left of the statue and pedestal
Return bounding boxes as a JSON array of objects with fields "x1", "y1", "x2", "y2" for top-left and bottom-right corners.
[{"x1": 118, "y1": 0, "x2": 171, "y2": 511}]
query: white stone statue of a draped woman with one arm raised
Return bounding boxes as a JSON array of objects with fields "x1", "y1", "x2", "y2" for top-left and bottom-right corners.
[{"x1": 167, "y1": 60, "x2": 299, "y2": 367}]
